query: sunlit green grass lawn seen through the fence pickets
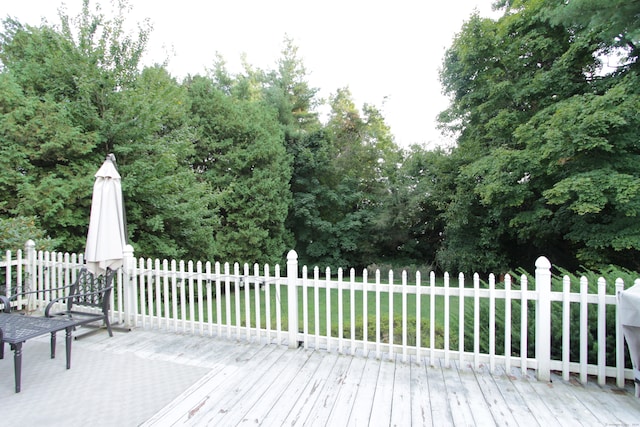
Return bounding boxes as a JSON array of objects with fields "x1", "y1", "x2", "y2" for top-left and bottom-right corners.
[{"x1": 140, "y1": 283, "x2": 519, "y2": 349}]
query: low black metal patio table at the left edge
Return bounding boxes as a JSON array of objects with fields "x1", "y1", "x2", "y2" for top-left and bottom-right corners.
[{"x1": 0, "y1": 313, "x2": 81, "y2": 393}]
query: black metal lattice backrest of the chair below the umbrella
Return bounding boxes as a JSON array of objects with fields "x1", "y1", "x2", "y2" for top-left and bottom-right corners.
[{"x1": 67, "y1": 268, "x2": 115, "y2": 313}]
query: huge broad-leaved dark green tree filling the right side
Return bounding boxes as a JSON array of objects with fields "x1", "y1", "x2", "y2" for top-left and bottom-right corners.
[{"x1": 440, "y1": 0, "x2": 640, "y2": 270}]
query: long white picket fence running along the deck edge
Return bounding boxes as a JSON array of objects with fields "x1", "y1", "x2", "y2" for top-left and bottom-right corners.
[{"x1": 0, "y1": 241, "x2": 640, "y2": 387}]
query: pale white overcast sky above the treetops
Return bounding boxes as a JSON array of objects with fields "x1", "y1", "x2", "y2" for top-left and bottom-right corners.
[{"x1": 0, "y1": 0, "x2": 496, "y2": 150}]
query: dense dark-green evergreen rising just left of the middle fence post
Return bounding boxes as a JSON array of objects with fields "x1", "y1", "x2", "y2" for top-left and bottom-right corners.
[{"x1": 186, "y1": 76, "x2": 291, "y2": 263}]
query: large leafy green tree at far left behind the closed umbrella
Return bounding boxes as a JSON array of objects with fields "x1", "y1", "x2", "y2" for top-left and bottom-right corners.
[{"x1": 0, "y1": 1, "x2": 213, "y2": 258}]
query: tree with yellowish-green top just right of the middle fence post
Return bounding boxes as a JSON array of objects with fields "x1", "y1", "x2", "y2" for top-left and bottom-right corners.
[{"x1": 289, "y1": 89, "x2": 397, "y2": 267}]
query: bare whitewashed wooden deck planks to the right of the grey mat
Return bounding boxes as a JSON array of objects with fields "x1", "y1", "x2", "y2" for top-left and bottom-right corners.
[{"x1": 136, "y1": 337, "x2": 640, "y2": 427}]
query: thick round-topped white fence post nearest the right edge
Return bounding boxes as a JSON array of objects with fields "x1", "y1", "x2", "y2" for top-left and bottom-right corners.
[{"x1": 536, "y1": 257, "x2": 551, "y2": 381}]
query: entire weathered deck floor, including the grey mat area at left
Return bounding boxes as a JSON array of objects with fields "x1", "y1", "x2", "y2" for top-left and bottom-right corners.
[{"x1": 0, "y1": 329, "x2": 640, "y2": 427}]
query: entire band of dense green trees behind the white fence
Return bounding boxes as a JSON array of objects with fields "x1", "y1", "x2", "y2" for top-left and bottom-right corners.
[{"x1": 0, "y1": 0, "x2": 640, "y2": 272}]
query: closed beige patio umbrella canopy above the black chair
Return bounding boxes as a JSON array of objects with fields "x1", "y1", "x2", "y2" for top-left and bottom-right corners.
[{"x1": 85, "y1": 154, "x2": 127, "y2": 275}]
